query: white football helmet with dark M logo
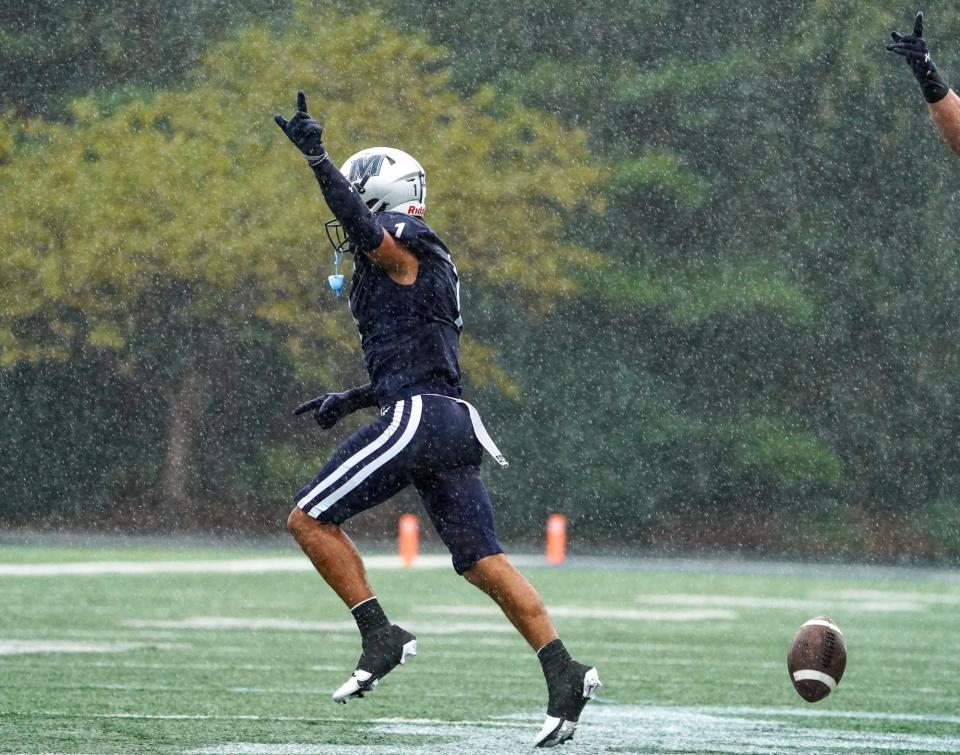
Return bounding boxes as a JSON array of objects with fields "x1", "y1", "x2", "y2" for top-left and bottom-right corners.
[{"x1": 340, "y1": 147, "x2": 427, "y2": 217}]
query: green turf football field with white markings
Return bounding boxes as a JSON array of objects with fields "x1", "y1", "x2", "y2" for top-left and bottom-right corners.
[{"x1": 0, "y1": 546, "x2": 960, "y2": 755}]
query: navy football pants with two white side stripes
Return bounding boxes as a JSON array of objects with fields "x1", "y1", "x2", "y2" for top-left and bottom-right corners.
[{"x1": 294, "y1": 395, "x2": 503, "y2": 574}]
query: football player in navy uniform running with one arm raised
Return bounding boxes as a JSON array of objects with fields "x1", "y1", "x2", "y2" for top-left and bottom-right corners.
[{"x1": 274, "y1": 92, "x2": 600, "y2": 747}]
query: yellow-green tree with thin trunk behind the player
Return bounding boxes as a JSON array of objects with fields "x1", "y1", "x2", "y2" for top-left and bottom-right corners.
[{"x1": 0, "y1": 2, "x2": 599, "y2": 520}]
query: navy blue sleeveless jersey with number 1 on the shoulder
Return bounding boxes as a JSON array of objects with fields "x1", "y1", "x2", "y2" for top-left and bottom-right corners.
[{"x1": 350, "y1": 212, "x2": 463, "y2": 407}]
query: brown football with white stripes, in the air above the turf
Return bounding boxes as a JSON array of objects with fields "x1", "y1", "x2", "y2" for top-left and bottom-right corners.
[{"x1": 787, "y1": 616, "x2": 847, "y2": 703}]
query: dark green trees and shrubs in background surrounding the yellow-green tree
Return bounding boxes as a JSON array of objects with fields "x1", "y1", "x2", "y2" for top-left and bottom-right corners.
[{"x1": 0, "y1": 0, "x2": 960, "y2": 559}]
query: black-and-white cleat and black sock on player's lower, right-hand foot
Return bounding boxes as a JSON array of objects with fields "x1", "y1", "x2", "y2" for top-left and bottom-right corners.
[{"x1": 534, "y1": 640, "x2": 602, "y2": 747}]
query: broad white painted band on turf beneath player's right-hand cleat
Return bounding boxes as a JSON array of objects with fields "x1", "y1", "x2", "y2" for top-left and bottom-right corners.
[{"x1": 20, "y1": 704, "x2": 960, "y2": 755}]
